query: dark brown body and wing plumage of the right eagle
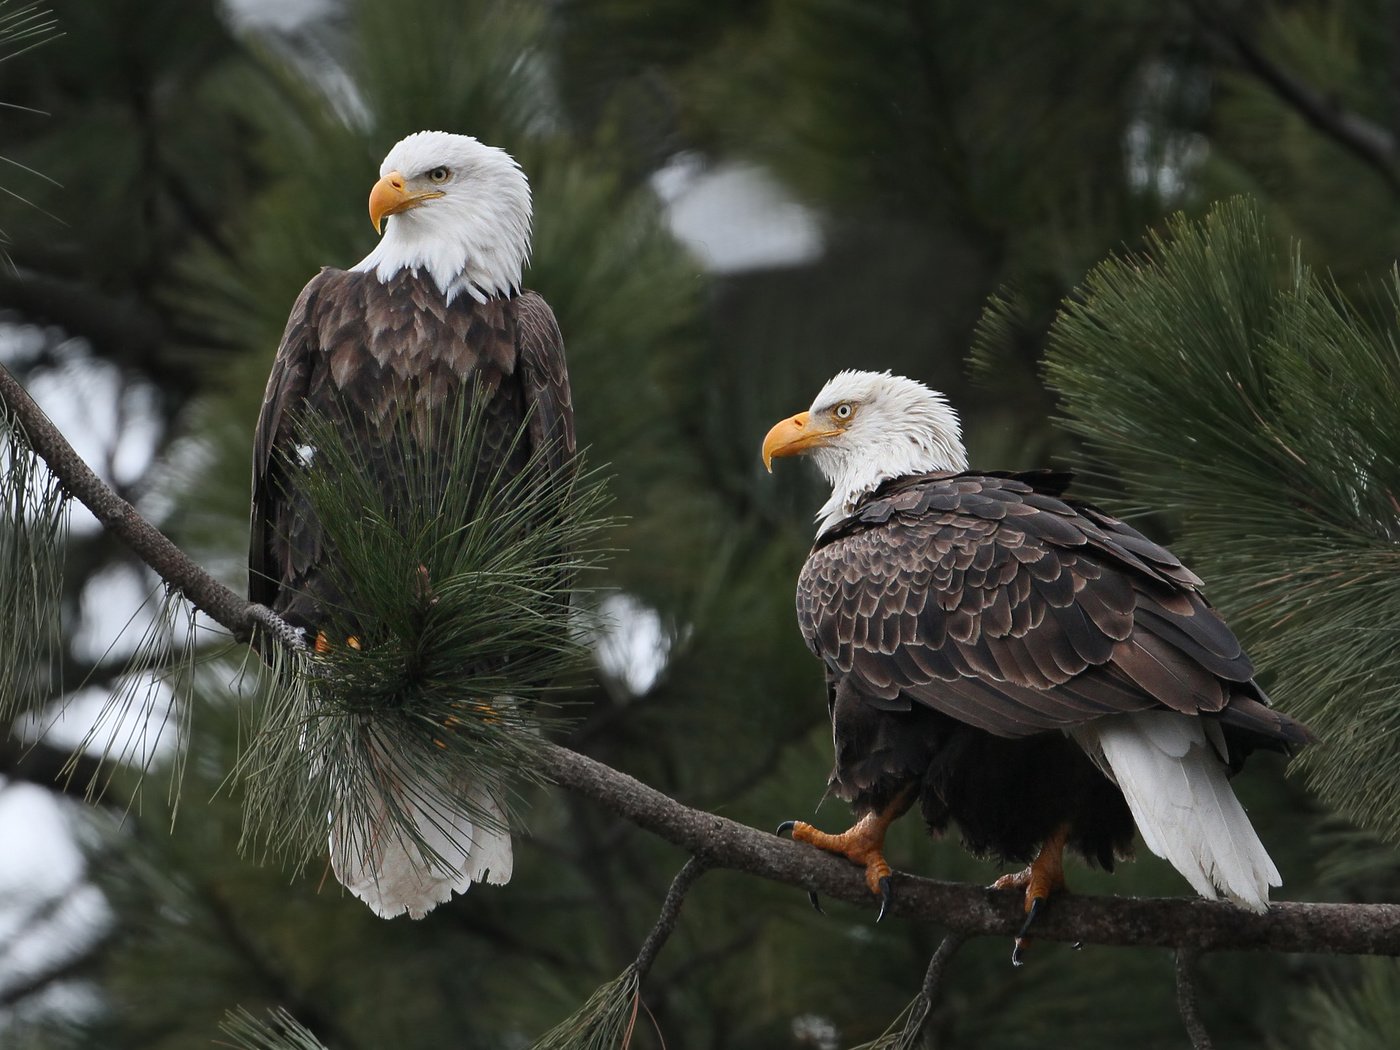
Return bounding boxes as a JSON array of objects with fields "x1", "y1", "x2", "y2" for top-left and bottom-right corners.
[{"x1": 797, "y1": 473, "x2": 1308, "y2": 868}]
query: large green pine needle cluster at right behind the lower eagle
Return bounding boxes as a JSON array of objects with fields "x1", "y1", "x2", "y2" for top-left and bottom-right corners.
[{"x1": 1019, "y1": 200, "x2": 1400, "y2": 841}]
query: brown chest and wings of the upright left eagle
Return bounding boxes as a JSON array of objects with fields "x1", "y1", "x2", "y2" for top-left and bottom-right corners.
[{"x1": 248, "y1": 269, "x2": 574, "y2": 638}]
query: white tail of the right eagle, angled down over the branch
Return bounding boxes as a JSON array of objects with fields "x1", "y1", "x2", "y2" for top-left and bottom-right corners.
[{"x1": 1075, "y1": 711, "x2": 1282, "y2": 913}]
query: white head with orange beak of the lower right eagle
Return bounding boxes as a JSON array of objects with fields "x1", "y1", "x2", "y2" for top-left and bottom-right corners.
[{"x1": 763, "y1": 370, "x2": 967, "y2": 531}]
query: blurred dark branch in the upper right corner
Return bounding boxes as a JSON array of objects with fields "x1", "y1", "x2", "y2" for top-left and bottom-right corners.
[{"x1": 1187, "y1": 0, "x2": 1400, "y2": 193}]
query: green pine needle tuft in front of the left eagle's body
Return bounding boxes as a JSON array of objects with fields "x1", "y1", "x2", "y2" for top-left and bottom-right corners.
[{"x1": 234, "y1": 392, "x2": 603, "y2": 865}]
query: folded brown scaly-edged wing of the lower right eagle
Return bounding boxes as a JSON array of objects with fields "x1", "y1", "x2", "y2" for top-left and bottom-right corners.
[{"x1": 798, "y1": 475, "x2": 1301, "y2": 742}]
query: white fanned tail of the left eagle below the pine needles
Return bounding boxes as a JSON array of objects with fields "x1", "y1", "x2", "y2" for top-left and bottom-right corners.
[{"x1": 330, "y1": 763, "x2": 514, "y2": 918}]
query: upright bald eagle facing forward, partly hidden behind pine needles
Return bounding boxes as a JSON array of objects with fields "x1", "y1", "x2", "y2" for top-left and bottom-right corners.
[{"x1": 248, "y1": 132, "x2": 574, "y2": 917}]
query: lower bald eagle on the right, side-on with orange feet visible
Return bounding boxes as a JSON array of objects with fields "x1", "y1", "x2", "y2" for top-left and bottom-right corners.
[{"x1": 763, "y1": 371, "x2": 1310, "y2": 963}]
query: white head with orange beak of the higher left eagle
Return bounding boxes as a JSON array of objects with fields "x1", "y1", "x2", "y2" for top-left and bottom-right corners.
[{"x1": 353, "y1": 132, "x2": 531, "y2": 302}]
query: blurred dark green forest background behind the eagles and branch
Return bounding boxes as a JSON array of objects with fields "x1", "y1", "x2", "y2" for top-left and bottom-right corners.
[{"x1": 0, "y1": 0, "x2": 1400, "y2": 1050}]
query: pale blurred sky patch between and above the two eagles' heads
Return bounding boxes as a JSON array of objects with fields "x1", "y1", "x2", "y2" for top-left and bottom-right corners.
[{"x1": 651, "y1": 153, "x2": 823, "y2": 273}]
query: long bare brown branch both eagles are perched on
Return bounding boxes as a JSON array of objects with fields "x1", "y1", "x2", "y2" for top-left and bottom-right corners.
[{"x1": 0, "y1": 368, "x2": 1400, "y2": 955}]
